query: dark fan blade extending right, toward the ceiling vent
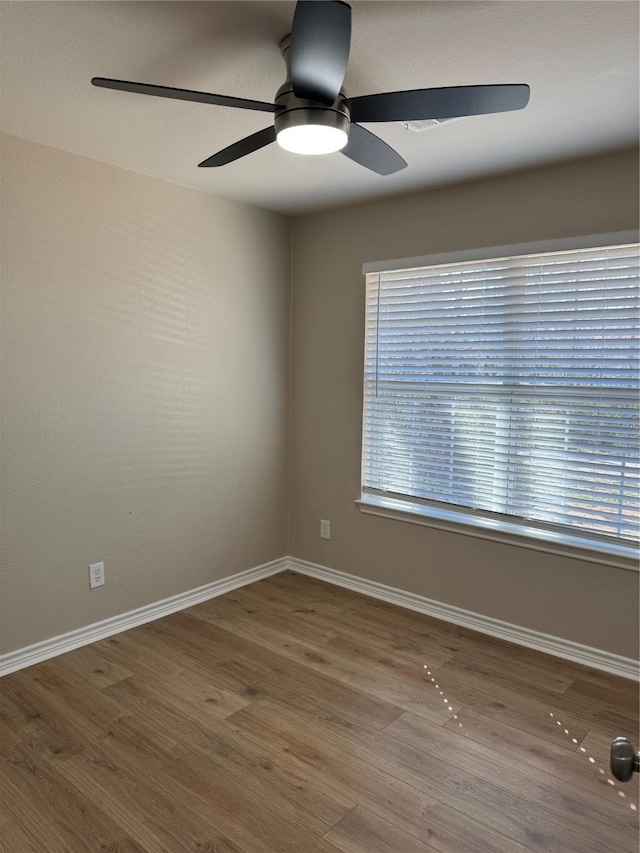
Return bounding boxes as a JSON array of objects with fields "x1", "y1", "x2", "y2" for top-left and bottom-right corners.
[{"x1": 349, "y1": 84, "x2": 529, "y2": 121}]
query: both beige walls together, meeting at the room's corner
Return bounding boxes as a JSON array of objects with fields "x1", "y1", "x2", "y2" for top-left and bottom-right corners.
[{"x1": 0, "y1": 137, "x2": 638, "y2": 657}]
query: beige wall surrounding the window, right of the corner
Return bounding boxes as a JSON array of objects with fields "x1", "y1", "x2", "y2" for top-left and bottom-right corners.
[{"x1": 290, "y1": 152, "x2": 638, "y2": 657}]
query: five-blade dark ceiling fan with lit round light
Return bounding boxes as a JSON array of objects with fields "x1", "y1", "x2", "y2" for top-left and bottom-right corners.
[{"x1": 91, "y1": 0, "x2": 529, "y2": 175}]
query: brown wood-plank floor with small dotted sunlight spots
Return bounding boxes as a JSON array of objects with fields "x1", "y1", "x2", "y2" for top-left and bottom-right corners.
[{"x1": 0, "y1": 573, "x2": 638, "y2": 853}]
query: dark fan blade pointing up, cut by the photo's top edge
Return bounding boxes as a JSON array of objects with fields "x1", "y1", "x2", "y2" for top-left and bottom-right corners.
[{"x1": 289, "y1": 0, "x2": 351, "y2": 104}]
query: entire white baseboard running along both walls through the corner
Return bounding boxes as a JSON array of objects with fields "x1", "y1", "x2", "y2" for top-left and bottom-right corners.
[{"x1": 0, "y1": 557, "x2": 640, "y2": 680}]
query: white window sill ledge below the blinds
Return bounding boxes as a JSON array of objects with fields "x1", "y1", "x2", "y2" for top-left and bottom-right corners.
[{"x1": 356, "y1": 495, "x2": 640, "y2": 572}]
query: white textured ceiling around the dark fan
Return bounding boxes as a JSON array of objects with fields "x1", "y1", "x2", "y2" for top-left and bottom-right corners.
[{"x1": 0, "y1": 0, "x2": 639, "y2": 214}]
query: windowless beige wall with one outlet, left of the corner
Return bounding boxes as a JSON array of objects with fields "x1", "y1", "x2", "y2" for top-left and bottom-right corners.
[{"x1": 2, "y1": 137, "x2": 290, "y2": 652}]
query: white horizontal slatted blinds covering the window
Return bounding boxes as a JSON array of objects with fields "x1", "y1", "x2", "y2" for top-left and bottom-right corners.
[{"x1": 362, "y1": 244, "x2": 640, "y2": 543}]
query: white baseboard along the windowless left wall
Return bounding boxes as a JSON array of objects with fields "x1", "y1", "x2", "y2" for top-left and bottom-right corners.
[{"x1": 0, "y1": 558, "x2": 287, "y2": 676}]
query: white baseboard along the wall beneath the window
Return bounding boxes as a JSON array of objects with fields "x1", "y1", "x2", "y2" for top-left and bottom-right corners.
[{"x1": 285, "y1": 557, "x2": 640, "y2": 681}]
